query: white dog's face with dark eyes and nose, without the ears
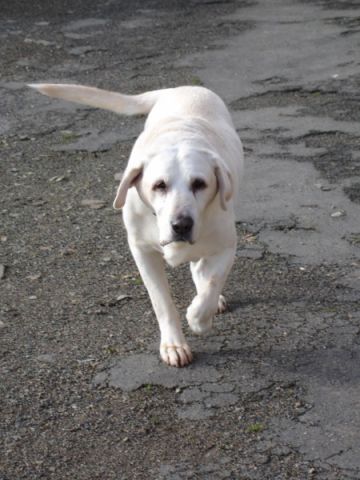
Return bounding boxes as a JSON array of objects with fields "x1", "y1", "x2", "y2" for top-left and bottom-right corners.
[{"x1": 138, "y1": 149, "x2": 217, "y2": 247}]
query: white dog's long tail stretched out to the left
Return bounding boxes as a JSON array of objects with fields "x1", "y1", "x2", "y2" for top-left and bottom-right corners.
[{"x1": 28, "y1": 83, "x2": 164, "y2": 115}]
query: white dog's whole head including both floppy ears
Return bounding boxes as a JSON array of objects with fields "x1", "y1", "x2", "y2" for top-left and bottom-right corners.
[{"x1": 114, "y1": 146, "x2": 233, "y2": 246}]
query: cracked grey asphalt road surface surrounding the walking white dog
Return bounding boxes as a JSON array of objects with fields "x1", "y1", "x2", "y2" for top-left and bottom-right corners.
[{"x1": 0, "y1": 0, "x2": 360, "y2": 480}]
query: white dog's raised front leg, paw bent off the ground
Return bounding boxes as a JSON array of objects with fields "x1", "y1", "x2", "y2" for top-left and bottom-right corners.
[{"x1": 186, "y1": 247, "x2": 235, "y2": 334}]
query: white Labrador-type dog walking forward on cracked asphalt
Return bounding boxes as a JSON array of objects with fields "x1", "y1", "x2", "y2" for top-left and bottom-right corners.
[{"x1": 30, "y1": 84, "x2": 243, "y2": 367}]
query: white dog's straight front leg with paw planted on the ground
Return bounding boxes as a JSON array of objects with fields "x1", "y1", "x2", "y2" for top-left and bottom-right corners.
[{"x1": 130, "y1": 245, "x2": 192, "y2": 367}]
